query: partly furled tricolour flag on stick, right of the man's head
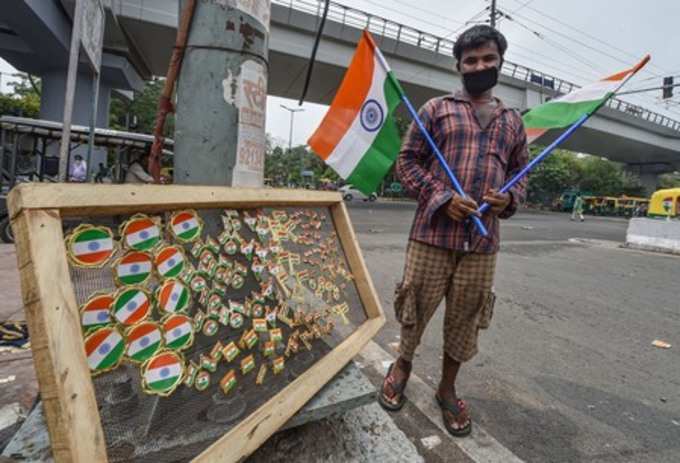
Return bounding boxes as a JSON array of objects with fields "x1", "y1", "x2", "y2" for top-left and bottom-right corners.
[{"x1": 522, "y1": 55, "x2": 650, "y2": 143}]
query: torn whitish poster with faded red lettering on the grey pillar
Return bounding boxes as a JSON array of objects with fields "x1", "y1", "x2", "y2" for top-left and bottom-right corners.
[{"x1": 231, "y1": 60, "x2": 267, "y2": 187}]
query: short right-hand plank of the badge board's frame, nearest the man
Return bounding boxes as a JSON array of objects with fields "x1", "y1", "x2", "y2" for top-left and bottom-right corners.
[{"x1": 330, "y1": 202, "x2": 385, "y2": 320}]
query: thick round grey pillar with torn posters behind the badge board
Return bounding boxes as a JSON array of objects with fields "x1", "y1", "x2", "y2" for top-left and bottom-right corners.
[{"x1": 174, "y1": 0, "x2": 270, "y2": 187}]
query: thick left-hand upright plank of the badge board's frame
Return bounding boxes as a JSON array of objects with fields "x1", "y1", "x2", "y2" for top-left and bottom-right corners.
[{"x1": 14, "y1": 210, "x2": 107, "y2": 463}]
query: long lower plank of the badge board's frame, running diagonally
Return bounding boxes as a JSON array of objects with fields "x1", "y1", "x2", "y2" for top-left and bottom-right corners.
[{"x1": 192, "y1": 318, "x2": 384, "y2": 463}]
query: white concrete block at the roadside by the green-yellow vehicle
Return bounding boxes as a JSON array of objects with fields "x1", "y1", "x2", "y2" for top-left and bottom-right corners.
[{"x1": 626, "y1": 218, "x2": 680, "y2": 254}]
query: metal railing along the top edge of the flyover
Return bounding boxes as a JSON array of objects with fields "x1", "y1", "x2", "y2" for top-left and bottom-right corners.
[{"x1": 272, "y1": 0, "x2": 680, "y2": 131}]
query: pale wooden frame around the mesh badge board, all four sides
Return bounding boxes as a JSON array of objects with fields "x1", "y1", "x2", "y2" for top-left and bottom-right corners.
[{"x1": 8, "y1": 184, "x2": 385, "y2": 463}]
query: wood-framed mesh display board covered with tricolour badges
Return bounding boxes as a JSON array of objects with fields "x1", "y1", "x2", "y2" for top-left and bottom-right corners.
[{"x1": 9, "y1": 184, "x2": 385, "y2": 463}]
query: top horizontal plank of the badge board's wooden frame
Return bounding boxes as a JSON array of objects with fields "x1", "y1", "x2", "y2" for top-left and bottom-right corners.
[{"x1": 7, "y1": 183, "x2": 342, "y2": 217}]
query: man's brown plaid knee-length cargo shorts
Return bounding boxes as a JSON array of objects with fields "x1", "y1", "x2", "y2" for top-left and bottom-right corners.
[{"x1": 394, "y1": 241, "x2": 496, "y2": 362}]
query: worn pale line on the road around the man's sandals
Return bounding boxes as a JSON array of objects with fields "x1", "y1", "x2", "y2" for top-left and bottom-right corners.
[{"x1": 360, "y1": 341, "x2": 524, "y2": 463}]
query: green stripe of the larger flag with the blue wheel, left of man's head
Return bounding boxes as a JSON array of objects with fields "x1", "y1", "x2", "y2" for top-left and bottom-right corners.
[{"x1": 347, "y1": 72, "x2": 401, "y2": 195}]
